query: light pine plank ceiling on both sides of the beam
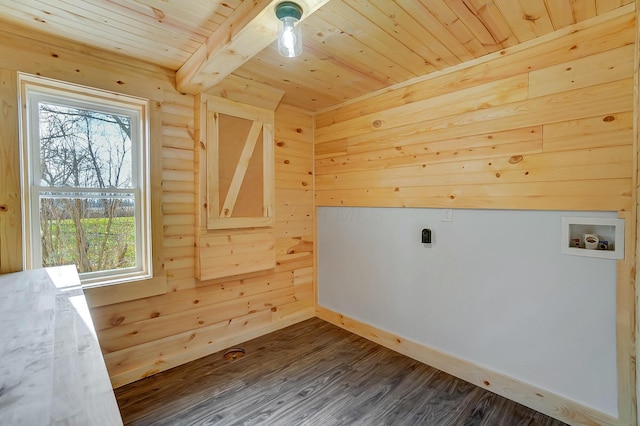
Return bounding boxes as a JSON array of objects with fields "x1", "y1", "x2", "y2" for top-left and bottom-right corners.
[{"x1": 0, "y1": 0, "x2": 634, "y2": 111}]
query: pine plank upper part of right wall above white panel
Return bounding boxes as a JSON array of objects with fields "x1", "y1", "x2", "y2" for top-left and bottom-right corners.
[{"x1": 316, "y1": 13, "x2": 635, "y2": 211}]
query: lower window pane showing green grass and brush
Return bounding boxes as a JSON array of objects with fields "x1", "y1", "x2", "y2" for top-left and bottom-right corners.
[{"x1": 40, "y1": 193, "x2": 136, "y2": 273}]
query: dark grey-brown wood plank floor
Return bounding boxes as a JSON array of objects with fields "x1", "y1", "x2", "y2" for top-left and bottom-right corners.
[{"x1": 116, "y1": 318, "x2": 564, "y2": 426}]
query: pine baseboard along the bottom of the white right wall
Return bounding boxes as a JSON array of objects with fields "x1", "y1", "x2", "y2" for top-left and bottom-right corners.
[{"x1": 316, "y1": 306, "x2": 628, "y2": 426}]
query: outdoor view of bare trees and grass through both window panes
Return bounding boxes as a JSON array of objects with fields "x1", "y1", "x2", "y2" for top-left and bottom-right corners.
[{"x1": 36, "y1": 102, "x2": 136, "y2": 273}]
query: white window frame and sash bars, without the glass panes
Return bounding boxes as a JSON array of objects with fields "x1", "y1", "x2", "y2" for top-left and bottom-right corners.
[{"x1": 18, "y1": 73, "x2": 153, "y2": 287}]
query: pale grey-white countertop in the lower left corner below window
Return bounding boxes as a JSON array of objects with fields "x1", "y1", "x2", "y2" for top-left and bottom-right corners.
[{"x1": 0, "y1": 266, "x2": 122, "y2": 426}]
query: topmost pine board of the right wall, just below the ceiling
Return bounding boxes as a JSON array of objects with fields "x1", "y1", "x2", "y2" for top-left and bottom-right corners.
[{"x1": 316, "y1": 2, "x2": 635, "y2": 129}]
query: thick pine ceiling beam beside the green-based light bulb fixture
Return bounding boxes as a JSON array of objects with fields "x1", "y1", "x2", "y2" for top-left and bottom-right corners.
[{"x1": 176, "y1": 0, "x2": 329, "y2": 95}]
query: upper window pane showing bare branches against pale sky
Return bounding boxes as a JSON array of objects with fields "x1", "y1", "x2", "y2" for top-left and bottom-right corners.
[{"x1": 38, "y1": 102, "x2": 134, "y2": 188}]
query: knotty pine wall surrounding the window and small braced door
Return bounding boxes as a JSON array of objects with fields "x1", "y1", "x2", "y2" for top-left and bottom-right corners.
[{"x1": 0, "y1": 28, "x2": 315, "y2": 386}]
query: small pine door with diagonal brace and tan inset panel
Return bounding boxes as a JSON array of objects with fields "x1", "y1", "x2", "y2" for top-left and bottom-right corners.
[{"x1": 206, "y1": 97, "x2": 274, "y2": 229}]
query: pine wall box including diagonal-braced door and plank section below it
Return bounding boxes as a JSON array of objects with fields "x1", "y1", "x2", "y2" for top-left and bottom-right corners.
[{"x1": 196, "y1": 94, "x2": 275, "y2": 280}]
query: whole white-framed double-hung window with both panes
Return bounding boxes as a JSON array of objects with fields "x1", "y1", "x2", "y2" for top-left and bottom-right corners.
[{"x1": 19, "y1": 74, "x2": 152, "y2": 286}]
